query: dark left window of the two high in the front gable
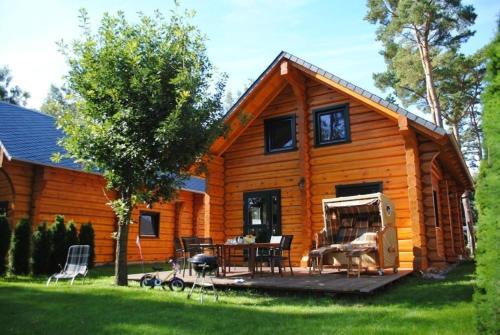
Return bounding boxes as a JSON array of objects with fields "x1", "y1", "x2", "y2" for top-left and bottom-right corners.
[{"x1": 264, "y1": 115, "x2": 296, "y2": 153}]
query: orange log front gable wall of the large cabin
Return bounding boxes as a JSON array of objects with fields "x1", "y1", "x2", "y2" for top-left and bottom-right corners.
[{"x1": 223, "y1": 79, "x2": 413, "y2": 267}]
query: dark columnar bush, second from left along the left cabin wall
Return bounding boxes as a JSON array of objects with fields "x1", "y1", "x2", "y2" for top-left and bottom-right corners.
[{"x1": 9, "y1": 218, "x2": 31, "y2": 275}]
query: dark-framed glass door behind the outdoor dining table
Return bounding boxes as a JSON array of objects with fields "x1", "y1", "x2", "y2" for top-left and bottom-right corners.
[{"x1": 243, "y1": 190, "x2": 281, "y2": 242}]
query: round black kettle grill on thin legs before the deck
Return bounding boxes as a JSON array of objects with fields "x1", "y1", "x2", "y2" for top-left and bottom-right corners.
[{"x1": 188, "y1": 254, "x2": 219, "y2": 303}]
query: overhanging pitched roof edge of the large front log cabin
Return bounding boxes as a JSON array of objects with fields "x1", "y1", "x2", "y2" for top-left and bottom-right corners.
[{"x1": 212, "y1": 51, "x2": 474, "y2": 188}]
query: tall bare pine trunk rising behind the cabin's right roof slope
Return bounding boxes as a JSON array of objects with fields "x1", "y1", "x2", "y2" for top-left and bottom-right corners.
[{"x1": 415, "y1": 31, "x2": 443, "y2": 127}]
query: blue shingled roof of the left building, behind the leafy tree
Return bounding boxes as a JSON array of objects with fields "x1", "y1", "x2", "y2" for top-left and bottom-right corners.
[{"x1": 0, "y1": 101, "x2": 205, "y2": 192}]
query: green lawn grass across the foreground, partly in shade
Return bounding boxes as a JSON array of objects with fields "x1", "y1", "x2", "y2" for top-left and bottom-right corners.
[{"x1": 0, "y1": 263, "x2": 475, "y2": 335}]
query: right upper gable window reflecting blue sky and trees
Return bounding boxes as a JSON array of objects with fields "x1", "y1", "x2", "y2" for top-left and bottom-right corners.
[{"x1": 314, "y1": 105, "x2": 351, "y2": 146}]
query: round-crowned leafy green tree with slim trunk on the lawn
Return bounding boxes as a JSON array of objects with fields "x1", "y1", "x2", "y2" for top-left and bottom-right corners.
[{"x1": 59, "y1": 10, "x2": 225, "y2": 285}]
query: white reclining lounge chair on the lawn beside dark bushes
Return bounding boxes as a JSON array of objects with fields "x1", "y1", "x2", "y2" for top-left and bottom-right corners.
[{"x1": 47, "y1": 245, "x2": 90, "y2": 286}]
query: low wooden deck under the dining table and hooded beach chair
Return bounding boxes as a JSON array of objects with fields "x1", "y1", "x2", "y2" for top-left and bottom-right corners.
[{"x1": 128, "y1": 267, "x2": 412, "y2": 294}]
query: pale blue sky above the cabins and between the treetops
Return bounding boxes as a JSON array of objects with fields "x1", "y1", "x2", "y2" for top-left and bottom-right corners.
[{"x1": 0, "y1": 0, "x2": 500, "y2": 121}]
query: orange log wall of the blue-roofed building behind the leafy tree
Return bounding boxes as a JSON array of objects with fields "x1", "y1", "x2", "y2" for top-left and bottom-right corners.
[{"x1": 0, "y1": 160, "x2": 201, "y2": 263}]
